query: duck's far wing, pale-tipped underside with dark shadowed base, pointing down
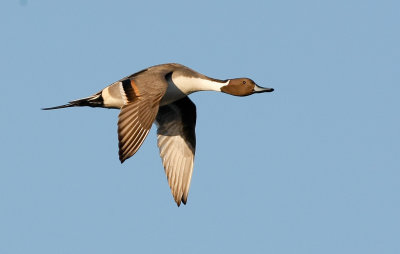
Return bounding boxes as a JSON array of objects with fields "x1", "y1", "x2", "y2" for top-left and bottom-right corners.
[{"x1": 156, "y1": 97, "x2": 196, "y2": 206}]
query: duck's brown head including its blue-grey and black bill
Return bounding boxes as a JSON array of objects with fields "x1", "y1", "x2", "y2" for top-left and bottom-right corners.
[{"x1": 221, "y1": 78, "x2": 274, "y2": 96}]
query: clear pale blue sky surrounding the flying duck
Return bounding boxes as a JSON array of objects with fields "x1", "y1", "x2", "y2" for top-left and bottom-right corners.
[{"x1": 0, "y1": 0, "x2": 400, "y2": 254}]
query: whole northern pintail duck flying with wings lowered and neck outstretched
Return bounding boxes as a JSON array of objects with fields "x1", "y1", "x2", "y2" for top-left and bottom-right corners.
[{"x1": 44, "y1": 63, "x2": 274, "y2": 206}]
